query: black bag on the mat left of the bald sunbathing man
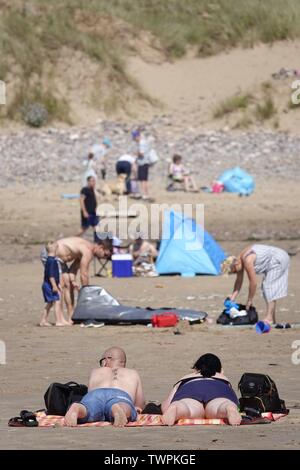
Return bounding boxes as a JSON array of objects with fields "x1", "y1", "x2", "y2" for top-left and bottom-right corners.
[{"x1": 44, "y1": 382, "x2": 88, "y2": 416}]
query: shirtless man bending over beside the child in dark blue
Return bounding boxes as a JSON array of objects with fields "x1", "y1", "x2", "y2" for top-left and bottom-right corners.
[{"x1": 41, "y1": 237, "x2": 112, "y2": 323}]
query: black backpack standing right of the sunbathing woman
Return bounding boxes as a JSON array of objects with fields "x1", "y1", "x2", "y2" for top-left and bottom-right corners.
[{"x1": 239, "y1": 373, "x2": 288, "y2": 414}]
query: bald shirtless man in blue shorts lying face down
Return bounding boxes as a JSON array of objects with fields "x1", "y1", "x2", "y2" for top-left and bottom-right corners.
[{"x1": 65, "y1": 347, "x2": 145, "y2": 427}]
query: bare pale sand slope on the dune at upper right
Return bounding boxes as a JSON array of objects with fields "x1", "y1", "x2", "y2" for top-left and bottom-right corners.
[{"x1": 129, "y1": 41, "x2": 300, "y2": 134}]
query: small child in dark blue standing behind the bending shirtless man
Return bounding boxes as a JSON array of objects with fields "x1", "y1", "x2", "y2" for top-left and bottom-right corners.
[{"x1": 40, "y1": 242, "x2": 70, "y2": 326}]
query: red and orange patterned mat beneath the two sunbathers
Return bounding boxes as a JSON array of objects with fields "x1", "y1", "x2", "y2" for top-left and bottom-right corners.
[{"x1": 36, "y1": 412, "x2": 286, "y2": 428}]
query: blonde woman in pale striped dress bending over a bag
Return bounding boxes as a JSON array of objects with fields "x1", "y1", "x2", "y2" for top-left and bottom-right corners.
[{"x1": 222, "y1": 245, "x2": 290, "y2": 324}]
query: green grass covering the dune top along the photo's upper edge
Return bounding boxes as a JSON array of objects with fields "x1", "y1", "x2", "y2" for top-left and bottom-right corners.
[{"x1": 0, "y1": 0, "x2": 300, "y2": 123}]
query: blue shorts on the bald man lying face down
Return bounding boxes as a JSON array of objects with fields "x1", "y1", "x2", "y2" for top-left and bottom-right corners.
[{"x1": 78, "y1": 388, "x2": 137, "y2": 424}]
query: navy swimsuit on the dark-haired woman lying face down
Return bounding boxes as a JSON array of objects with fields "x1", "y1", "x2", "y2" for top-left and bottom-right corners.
[{"x1": 172, "y1": 377, "x2": 239, "y2": 407}]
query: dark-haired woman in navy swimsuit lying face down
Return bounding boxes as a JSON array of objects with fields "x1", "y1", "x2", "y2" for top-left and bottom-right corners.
[{"x1": 162, "y1": 354, "x2": 241, "y2": 426}]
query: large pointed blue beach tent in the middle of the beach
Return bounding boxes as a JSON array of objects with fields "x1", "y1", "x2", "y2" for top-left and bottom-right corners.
[{"x1": 156, "y1": 211, "x2": 225, "y2": 276}]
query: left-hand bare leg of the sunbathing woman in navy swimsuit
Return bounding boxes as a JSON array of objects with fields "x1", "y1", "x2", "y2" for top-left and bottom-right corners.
[{"x1": 162, "y1": 398, "x2": 205, "y2": 426}]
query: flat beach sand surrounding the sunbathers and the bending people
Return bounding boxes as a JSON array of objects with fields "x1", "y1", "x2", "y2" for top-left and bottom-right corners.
[{"x1": 0, "y1": 181, "x2": 300, "y2": 450}]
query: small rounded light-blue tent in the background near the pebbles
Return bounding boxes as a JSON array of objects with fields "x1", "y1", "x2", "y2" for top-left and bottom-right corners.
[{"x1": 218, "y1": 166, "x2": 255, "y2": 196}]
